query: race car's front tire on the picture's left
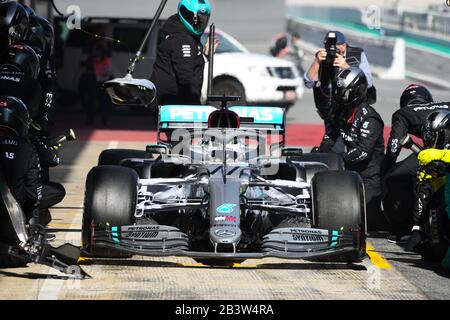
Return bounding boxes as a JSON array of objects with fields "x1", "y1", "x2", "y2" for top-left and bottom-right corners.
[{"x1": 82, "y1": 166, "x2": 139, "y2": 258}]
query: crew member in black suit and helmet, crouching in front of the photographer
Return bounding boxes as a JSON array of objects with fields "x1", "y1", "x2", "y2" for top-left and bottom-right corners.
[{"x1": 322, "y1": 67, "x2": 386, "y2": 232}]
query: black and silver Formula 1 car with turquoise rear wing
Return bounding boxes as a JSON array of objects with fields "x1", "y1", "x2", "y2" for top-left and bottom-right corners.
[{"x1": 82, "y1": 97, "x2": 366, "y2": 265}]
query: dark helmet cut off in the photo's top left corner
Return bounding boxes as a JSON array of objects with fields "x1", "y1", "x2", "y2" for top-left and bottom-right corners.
[{"x1": 0, "y1": 1, "x2": 29, "y2": 48}]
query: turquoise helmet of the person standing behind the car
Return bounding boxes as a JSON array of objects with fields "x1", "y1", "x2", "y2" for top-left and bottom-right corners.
[{"x1": 178, "y1": 0, "x2": 211, "y2": 36}]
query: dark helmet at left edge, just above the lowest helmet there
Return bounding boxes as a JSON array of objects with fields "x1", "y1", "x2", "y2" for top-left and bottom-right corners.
[{"x1": 0, "y1": 43, "x2": 41, "y2": 80}]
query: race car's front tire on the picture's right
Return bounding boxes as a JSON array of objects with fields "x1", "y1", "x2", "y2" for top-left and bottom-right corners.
[{"x1": 312, "y1": 171, "x2": 366, "y2": 262}]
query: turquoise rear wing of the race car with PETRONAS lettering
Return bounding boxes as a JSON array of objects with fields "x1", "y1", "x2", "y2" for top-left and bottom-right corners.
[{"x1": 158, "y1": 105, "x2": 286, "y2": 131}]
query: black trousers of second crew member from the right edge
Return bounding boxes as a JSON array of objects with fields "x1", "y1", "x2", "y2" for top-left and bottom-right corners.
[{"x1": 382, "y1": 154, "x2": 418, "y2": 235}]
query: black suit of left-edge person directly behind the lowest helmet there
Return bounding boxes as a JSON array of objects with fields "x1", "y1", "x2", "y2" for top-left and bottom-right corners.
[{"x1": 0, "y1": 70, "x2": 59, "y2": 182}]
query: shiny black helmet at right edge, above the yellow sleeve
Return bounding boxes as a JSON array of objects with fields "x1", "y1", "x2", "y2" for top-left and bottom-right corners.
[{"x1": 422, "y1": 110, "x2": 450, "y2": 149}]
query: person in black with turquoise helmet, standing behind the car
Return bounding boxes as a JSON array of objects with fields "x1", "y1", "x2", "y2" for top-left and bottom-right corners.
[{"x1": 151, "y1": 0, "x2": 217, "y2": 105}]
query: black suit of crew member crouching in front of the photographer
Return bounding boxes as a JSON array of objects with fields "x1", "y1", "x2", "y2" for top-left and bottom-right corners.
[{"x1": 324, "y1": 102, "x2": 385, "y2": 231}]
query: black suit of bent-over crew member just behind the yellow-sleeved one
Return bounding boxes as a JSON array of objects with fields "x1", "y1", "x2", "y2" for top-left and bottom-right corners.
[{"x1": 382, "y1": 102, "x2": 450, "y2": 235}]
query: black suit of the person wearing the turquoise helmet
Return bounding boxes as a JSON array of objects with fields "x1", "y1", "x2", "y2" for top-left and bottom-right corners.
[{"x1": 151, "y1": 14, "x2": 205, "y2": 105}]
